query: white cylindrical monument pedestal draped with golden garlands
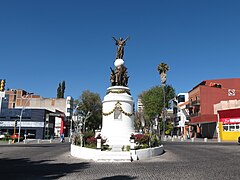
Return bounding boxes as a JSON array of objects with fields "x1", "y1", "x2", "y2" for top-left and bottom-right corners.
[{"x1": 101, "y1": 86, "x2": 134, "y2": 147}]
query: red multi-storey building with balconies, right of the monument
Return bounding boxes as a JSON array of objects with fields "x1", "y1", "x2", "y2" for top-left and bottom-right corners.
[{"x1": 187, "y1": 78, "x2": 240, "y2": 138}]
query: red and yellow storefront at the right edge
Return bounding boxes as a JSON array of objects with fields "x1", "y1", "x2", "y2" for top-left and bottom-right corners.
[{"x1": 218, "y1": 108, "x2": 240, "y2": 141}]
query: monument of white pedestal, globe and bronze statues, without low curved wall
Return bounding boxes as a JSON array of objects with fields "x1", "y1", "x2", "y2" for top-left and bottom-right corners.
[{"x1": 101, "y1": 37, "x2": 134, "y2": 148}]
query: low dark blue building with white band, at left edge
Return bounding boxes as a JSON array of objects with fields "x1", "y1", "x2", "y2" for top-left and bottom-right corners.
[{"x1": 0, "y1": 96, "x2": 55, "y2": 139}]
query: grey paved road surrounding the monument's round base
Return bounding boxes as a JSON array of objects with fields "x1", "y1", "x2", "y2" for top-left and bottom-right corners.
[{"x1": 0, "y1": 142, "x2": 240, "y2": 180}]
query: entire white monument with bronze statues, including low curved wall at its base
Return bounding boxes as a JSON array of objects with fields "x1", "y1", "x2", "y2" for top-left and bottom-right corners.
[{"x1": 71, "y1": 37, "x2": 163, "y2": 162}]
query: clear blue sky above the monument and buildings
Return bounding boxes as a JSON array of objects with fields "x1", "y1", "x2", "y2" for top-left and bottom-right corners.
[{"x1": 0, "y1": 0, "x2": 240, "y2": 101}]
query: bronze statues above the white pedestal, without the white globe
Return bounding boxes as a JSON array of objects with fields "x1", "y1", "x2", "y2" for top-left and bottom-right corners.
[{"x1": 110, "y1": 37, "x2": 129, "y2": 86}]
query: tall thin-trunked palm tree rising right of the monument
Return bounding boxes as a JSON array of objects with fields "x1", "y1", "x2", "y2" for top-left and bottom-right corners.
[{"x1": 157, "y1": 63, "x2": 169, "y2": 140}]
